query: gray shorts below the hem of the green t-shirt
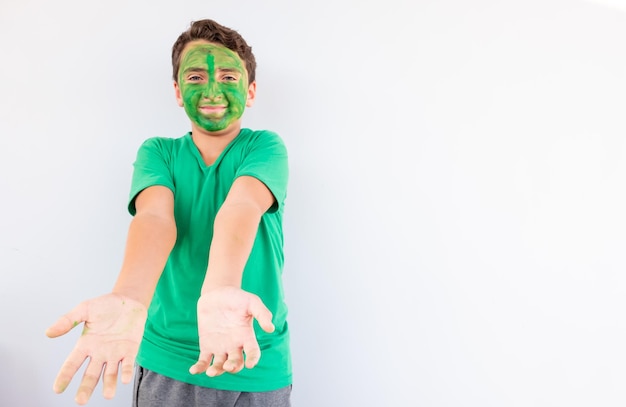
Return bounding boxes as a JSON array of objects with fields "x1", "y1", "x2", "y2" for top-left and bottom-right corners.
[{"x1": 133, "y1": 366, "x2": 291, "y2": 407}]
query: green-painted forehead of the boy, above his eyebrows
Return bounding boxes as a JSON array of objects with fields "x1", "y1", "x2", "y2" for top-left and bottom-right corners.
[{"x1": 178, "y1": 42, "x2": 246, "y2": 79}]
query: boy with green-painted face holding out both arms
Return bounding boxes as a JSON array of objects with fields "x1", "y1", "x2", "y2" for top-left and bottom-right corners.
[{"x1": 46, "y1": 20, "x2": 291, "y2": 407}]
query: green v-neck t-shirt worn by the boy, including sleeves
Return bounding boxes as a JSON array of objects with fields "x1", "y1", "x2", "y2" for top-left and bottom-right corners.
[{"x1": 128, "y1": 128, "x2": 291, "y2": 392}]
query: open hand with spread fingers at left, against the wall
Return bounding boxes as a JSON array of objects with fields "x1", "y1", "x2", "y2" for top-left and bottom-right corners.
[{"x1": 46, "y1": 294, "x2": 147, "y2": 405}]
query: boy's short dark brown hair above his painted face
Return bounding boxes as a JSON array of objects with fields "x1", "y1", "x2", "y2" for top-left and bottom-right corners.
[{"x1": 172, "y1": 19, "x2": 256, "y2": 83}]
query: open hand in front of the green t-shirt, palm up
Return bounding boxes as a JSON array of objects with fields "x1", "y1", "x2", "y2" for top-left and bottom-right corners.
[{"x1": 189, "y1": 287, "x2": 274, "y2": 376}]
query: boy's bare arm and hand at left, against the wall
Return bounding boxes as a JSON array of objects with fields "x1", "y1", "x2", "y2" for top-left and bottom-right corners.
[{"x1": 46, "y1": 186, "x2": 176, "y2": 405}]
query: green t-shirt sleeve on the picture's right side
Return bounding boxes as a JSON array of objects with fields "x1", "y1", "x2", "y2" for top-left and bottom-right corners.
[{"x1": 236, "y1": 131, "x2": 289, "y2": 212}]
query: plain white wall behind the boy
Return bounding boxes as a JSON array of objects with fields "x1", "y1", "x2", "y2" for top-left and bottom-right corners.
[{"x1": 0, "y1": 0, "x2": 626, "y2": 407}]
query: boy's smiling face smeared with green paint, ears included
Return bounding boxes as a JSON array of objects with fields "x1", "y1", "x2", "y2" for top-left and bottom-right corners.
[{"x1": 174, "y1": 41, "x2": 256, "y2": 132}]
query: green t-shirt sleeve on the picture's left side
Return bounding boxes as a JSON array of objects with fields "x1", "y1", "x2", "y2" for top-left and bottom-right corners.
[{"x1": 128, "y1": 138, "x2": 175, "y2": 216}]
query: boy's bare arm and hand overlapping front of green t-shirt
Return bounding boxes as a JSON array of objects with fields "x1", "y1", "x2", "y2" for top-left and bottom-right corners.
[{"x1": 189, "y1": 176, "x2": 275, "y2": 376}]
